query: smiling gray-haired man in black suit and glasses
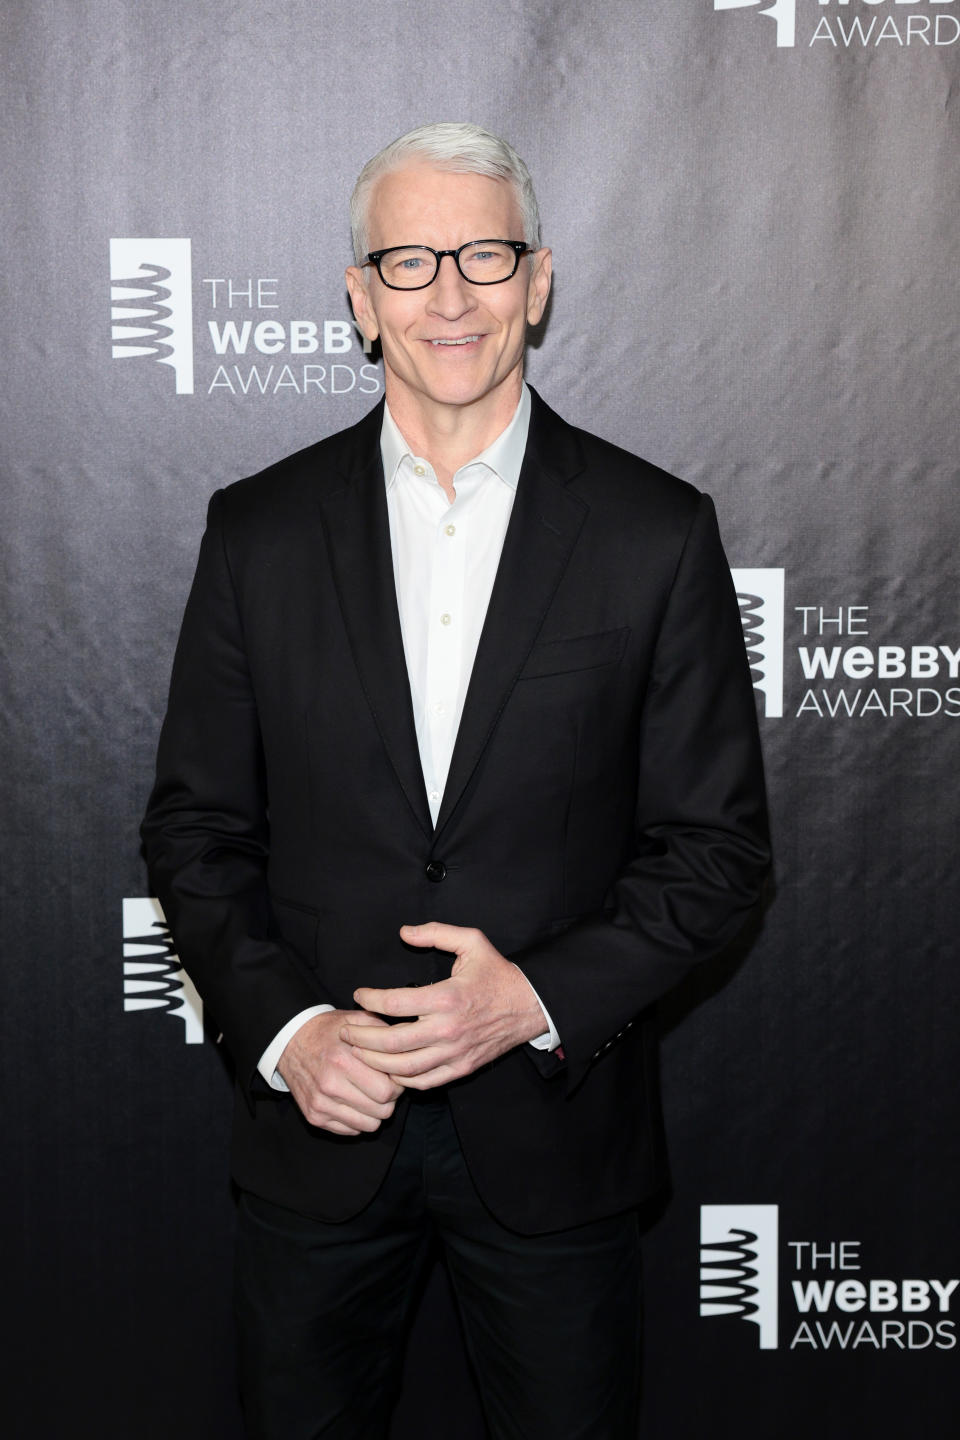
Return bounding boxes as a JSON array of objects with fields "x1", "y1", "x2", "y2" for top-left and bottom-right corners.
[{"x1": 144, "y1": 124, "x2": 767, "y2": 1440}]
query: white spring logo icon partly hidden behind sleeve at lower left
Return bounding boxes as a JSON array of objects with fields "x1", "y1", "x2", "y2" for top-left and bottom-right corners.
[{"x1": 124, "y1": 897, "x2": 203, "y2": 1045}]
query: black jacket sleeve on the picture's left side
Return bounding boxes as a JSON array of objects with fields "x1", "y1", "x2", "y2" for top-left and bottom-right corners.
[{"x1": 141, "y1": 491, "x2": 328, "y2": 1090}]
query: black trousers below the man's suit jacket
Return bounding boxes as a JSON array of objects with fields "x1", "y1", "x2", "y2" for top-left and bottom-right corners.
[{"x1": 236, "y1": 1092, "x2": 640, "y2": 1440}]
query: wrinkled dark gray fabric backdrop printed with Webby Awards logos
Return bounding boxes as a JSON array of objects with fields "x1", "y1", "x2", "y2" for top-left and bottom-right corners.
[{"x1": 0, "y1": 0, "x2": 960, "y2": 1440}]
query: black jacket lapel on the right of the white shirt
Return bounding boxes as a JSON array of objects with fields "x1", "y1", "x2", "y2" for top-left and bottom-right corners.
[{"x1": 436, "y1": 392, "x2": 587, "y2": 837}]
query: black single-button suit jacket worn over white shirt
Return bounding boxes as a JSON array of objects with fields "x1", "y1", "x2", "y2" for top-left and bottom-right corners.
[{"x1": 142, "y1": 385, "x2": 767, "y2": 1233}]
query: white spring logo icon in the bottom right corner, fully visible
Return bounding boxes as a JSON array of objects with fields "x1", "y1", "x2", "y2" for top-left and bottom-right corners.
[{"x1": 699, "y1": 1205, "x2": 779, "y2": 1349}]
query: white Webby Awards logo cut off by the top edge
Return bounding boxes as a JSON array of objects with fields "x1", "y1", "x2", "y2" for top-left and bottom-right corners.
[{"x1": 714, "y1": 0, "x2": 960, "y2": 50}]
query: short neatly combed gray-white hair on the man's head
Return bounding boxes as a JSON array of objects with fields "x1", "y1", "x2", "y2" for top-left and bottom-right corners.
[{"x1": 350, "y1": 121, "x2": 540, "y2": 265}]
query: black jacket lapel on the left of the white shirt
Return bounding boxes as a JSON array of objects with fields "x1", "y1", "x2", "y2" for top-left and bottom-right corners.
[{"x1": 320, "y1": 405, "x2": 433, "y2": 837}]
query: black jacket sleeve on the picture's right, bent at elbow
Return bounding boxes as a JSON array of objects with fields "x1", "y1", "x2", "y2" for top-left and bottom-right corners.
[{"x1": 511, "y1": 495, "x2": 770, "y2": 1086}]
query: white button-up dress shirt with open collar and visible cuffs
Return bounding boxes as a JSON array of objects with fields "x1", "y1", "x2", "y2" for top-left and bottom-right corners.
[{"x1": 258, "y1": 384, "x2": 560, "y2": 1090}]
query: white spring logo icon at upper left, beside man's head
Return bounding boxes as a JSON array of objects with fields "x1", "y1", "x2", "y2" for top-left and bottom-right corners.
[{"x1": 109, "y1": 239, "x2": 193, "y2": 395}]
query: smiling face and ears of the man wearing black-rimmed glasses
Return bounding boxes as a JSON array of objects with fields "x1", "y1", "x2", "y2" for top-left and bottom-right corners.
[{"x1": 347, "y1": 166, "x2": 550, "y2": 412}]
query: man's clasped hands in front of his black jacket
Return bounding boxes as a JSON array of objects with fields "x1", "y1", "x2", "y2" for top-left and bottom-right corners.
[{"x1": 278, "y1": 922, "x2": 547, "y2": 1135}]
